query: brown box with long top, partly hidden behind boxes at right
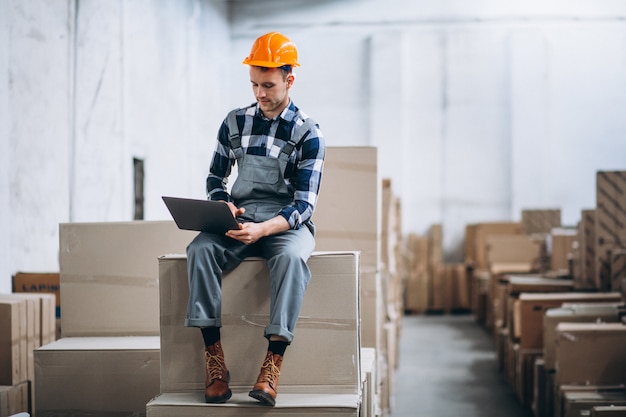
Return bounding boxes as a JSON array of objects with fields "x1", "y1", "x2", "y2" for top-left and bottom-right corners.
[{"x1": 513, "y1": 292, "x2": 622, "y2": 349}]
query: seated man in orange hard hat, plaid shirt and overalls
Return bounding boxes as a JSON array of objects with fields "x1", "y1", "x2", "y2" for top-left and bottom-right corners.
[{"x1": 185, "y1": 32, "x2": 325, "y2": 406}]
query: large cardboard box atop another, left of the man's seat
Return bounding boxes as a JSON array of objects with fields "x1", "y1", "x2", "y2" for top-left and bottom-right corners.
[{"x1": 34, "y1": 221, "x2": 193, "y2": 417}]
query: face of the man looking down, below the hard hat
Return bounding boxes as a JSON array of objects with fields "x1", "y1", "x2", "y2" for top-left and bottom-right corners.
[{"x1": 250, "y1": 66, "x2": 294, "y2": 119}]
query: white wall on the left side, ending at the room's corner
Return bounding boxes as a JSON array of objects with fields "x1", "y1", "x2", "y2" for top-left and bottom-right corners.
[{"x1": 0, "y1": 0, "x2": 230, "y2": 292}]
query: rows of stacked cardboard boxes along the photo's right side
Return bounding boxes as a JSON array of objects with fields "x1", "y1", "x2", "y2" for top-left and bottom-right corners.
[{"x1": 456, "y1": 171, "x2": 626, "y2": 417}]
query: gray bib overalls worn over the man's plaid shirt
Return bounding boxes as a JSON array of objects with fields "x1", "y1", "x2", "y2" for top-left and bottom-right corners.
[{"x1": 185, "y1": 113, "x2": 315, "y2": 343}]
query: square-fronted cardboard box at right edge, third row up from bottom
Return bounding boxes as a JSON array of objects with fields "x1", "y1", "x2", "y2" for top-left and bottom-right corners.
[{"x1": 555, "y1": 323, "x2": 626, "y2": 385}]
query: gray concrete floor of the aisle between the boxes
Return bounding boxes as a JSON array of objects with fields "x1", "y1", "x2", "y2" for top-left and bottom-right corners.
[{"x1": 391, "y1": 315, "x2": 532, "y2": 417}]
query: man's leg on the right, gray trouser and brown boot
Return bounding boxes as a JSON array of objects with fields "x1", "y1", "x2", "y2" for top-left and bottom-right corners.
[{"x1": 250, "y1": 227, "x2": 315, "y2": 405}]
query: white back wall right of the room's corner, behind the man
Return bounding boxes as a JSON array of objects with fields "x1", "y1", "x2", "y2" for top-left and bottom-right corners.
[{"x1": 232, "y1": 0, "x2": 626, "y2": 260}]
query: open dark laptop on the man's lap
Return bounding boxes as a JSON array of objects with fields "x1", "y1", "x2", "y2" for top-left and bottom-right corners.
[{"x1": 161, "y1": 196, "x2": 239, "y2": 235}]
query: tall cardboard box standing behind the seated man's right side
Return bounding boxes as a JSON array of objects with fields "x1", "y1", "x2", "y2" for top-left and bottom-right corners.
[{"x1": 313, "y1": 146, "x2": 378, "y2": 351}]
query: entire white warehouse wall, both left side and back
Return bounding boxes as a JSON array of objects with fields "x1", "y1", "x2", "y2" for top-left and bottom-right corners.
[{"x1": 0, "y1": 0, "x2": 626, "y2": 292}]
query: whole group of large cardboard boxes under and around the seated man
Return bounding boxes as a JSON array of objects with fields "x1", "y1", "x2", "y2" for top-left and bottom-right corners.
[{"x1": 30, "y1": 147, "x2": 394, "y2": 417}]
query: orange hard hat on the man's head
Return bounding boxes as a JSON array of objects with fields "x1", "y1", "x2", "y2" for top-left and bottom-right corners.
[{"x1": 243, "y1": 32, "x2": 300, "y2": 68}]
